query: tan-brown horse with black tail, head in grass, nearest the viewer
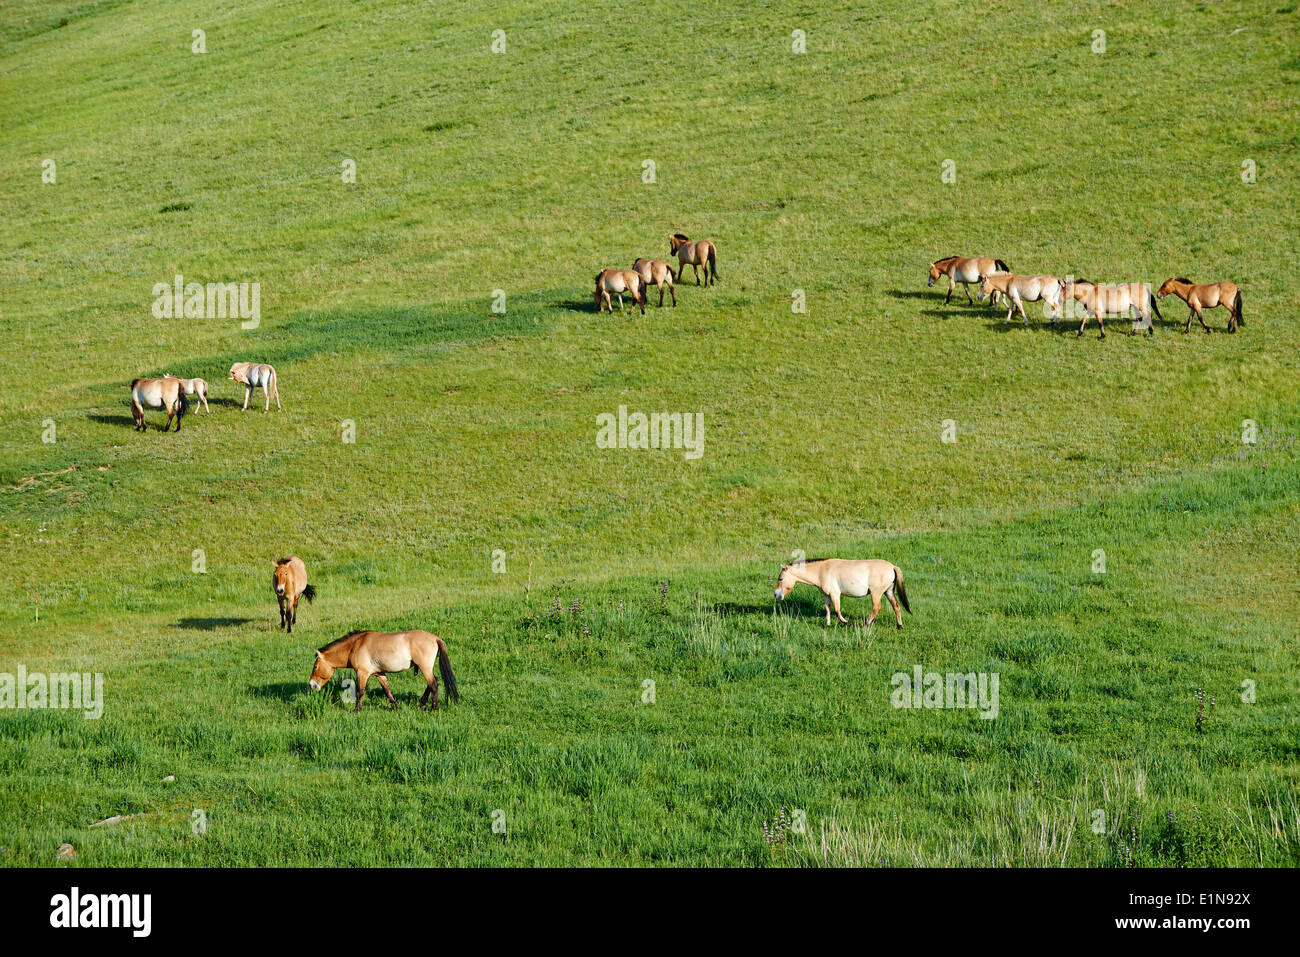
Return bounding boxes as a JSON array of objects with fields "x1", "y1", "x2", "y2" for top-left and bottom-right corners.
[{"x1": 307, "y1": 631, "x2": 460, "y2": 714}]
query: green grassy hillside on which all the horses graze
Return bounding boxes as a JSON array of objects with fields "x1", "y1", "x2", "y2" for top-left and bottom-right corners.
[{"x1": 0, "y1": 3, "x2": 1300, "y2": 866}]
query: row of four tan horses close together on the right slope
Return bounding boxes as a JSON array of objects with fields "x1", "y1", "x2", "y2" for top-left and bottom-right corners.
[{"x1": 928, "y1": 256, "x2": 1242, "y2": 339}]
